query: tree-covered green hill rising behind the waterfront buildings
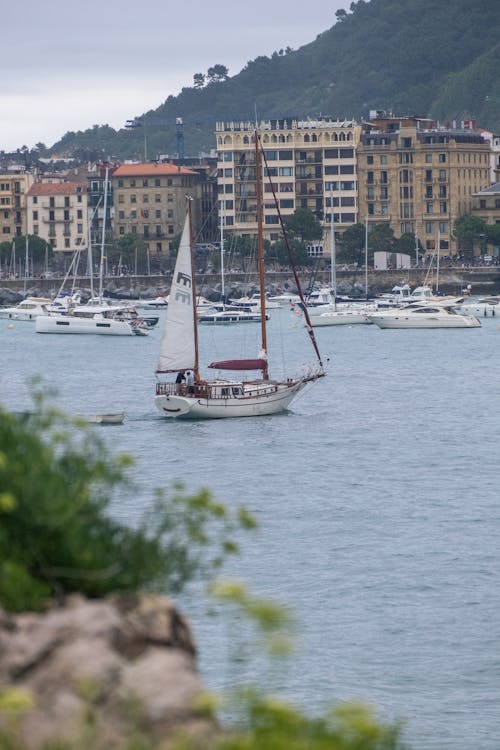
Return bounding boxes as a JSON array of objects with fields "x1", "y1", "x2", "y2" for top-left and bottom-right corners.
[{"x1": 51, "y1": 0, "x2": 500, "y2": 158}]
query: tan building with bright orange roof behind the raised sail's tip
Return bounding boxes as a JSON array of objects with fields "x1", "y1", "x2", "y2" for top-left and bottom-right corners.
[{"x1": 111, "y1": 163, "x2": 202, "y2": 255}]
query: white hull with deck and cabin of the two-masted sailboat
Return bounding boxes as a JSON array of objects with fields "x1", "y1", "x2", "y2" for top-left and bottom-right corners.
[{"x1": 155, "y1": 378, "x2": 315, "y2": 419}]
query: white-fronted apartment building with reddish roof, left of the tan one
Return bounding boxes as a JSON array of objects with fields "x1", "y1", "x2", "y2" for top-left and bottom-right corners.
[{"x1": 26, "y1": 182, "x2": 88, "y2": 253}]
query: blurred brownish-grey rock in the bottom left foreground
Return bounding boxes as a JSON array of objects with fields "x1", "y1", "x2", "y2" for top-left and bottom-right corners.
[{"x1": 0, "y1": 594, "x2": 216, "y2": 750}]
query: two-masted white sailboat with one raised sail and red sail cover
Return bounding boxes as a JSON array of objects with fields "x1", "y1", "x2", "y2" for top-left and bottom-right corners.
[{"x1": 155, "y1": 133, "x2": 325, "y2": 419}]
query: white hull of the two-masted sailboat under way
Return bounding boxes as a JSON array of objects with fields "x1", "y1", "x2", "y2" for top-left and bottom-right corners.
[{"x1": 155, "y1": 379, "x2": 309, "y2": 419}]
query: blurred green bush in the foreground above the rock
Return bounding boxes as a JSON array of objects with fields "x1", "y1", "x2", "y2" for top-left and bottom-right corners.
[{"x1": 0, "y1": 395, "x2": 251, "y2": 611}]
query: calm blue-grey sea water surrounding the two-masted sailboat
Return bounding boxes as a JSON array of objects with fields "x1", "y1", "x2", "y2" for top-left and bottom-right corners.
[{"x1": 0, "y1": 310, "x2": 500, "y2": 750}]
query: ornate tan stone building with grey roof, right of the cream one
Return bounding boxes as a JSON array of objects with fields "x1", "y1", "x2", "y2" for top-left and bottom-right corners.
[{"x1": 358, "y1": 112, "x2": 490, "y2": 255}]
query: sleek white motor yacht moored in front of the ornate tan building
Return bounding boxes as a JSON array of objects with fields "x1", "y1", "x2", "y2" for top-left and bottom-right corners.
[{"x1": 368, "y1": 302, "x2": 481, "y2": 328}]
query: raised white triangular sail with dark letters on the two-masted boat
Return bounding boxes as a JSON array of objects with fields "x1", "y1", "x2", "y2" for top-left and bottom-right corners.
[{"x1": 156, "y1": 214, "x2": 196, "y2": 372}]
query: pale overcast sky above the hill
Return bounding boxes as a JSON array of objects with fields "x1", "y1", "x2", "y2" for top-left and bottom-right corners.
[{"x1": 0, "y1": 0, "x2": 350, "y2": 151}]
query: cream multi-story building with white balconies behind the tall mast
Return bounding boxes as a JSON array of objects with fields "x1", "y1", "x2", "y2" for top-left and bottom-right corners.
[{"x1": 216, "y1": 117, "x2": 361, "y2": 247}]
